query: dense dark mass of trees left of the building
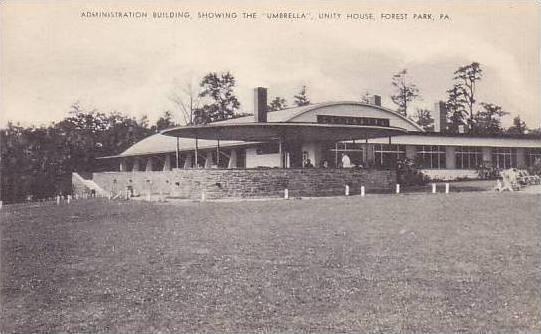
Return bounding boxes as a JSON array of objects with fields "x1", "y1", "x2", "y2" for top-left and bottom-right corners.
[{"x1": 0, "y1": 103, "x2": 154, "y2": 202}]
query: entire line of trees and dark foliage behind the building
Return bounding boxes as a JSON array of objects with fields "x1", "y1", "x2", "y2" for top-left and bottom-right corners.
[{"x1": 0, "y1": 63, "x2": 540, "y2": 202}]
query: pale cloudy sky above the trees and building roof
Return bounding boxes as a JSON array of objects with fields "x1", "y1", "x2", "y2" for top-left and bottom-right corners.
[{"x1": 0, "y1": 0, "x2": 541, "y2": 128}]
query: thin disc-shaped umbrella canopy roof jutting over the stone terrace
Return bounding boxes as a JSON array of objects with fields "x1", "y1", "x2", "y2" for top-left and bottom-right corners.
[{"x1": 162, "y1": 122, "x2": 407, "y2": 141}]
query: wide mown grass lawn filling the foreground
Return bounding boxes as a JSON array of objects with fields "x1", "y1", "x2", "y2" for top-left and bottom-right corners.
[{"x1": 0, "y1": 193, "x2": 541, "y2": 333}]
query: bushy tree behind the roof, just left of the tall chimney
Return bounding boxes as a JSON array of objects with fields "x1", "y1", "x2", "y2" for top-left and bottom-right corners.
[{"x1": 198, "y1": 72, "x2": 240, "y2": 123}]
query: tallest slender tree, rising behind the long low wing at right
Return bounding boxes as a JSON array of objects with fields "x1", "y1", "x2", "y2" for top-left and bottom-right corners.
[{"x1": 448, "y1": 62, "x2": 483, "y2": 129}]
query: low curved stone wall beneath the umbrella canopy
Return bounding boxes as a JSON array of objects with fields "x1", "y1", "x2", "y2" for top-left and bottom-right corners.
[{"x1": 92, "y1": 168, "x2": 396, "y2": 199}]
